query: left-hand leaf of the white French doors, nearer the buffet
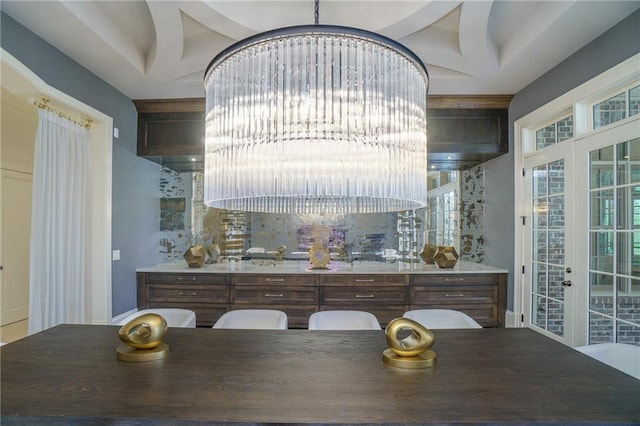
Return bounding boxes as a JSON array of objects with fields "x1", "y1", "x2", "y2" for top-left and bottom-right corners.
[{"x1": 523, "y1": 142, "x2": 581, "y2": 344}]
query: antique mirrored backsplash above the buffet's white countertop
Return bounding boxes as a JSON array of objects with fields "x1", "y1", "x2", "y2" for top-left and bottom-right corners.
[{"x1": 159, "y1": 166, "x2": 484, "y2": 263}]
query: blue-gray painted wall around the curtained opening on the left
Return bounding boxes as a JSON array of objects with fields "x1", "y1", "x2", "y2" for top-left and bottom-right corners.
[{"x1": 0, "y1": 13, "x2": 160, "y2": 316}]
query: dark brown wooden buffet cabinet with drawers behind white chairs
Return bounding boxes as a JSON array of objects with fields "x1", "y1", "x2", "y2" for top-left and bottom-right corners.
[{"x1": 137, "y1": 272, "x2": 507, "y2": 328}]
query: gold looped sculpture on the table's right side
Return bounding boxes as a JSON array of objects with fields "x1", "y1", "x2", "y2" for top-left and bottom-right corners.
[{"x1": 382, "y1": 318, "x2": 436, "y2": 368}]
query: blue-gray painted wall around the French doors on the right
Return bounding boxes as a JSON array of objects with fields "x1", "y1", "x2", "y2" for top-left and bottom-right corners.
[{"x1": 485, "y1": 10, "x2": 640, "y2": 310}]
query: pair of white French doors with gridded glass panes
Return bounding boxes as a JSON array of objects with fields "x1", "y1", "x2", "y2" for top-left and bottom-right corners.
[{"x1": 522, "y1": 120, "x2": 640, "y2": 346}]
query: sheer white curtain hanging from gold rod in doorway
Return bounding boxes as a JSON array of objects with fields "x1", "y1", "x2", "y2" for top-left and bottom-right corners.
[{"x1": 29, "y1": 109, "x2": 91, "y2": 334}]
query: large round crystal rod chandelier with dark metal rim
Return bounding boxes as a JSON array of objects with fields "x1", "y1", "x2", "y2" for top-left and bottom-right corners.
[{"x1": 204, "y1": 1, "x2": 429, "y2": 214}]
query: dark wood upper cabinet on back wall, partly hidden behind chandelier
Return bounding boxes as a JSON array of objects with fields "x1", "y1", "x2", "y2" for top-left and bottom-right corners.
[{"x1": 133, "y1": 95, "x2": 511, "y2": 172}]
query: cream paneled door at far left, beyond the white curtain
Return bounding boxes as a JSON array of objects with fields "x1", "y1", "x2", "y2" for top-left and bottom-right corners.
[{"x1": 0, "y1": 169, "x2": 33, "y2": 325}]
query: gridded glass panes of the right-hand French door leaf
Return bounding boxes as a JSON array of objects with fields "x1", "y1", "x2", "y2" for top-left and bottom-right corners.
[{"x1": 588, "y1": 138, "x2": 640, "y2": 344}]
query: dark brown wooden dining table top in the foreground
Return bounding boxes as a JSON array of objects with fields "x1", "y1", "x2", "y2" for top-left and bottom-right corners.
[{"x1": 0, "y1": 325, "x2": 640, "y2": 425}]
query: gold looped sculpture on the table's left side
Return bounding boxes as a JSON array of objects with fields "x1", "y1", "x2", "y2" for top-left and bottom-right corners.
[{"x1": 116, "y1": 314, "x2": 169, "y2": 362}]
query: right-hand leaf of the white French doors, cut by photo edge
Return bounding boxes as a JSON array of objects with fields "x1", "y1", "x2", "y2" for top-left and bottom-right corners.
[{"x1": 575, "y1": 119, "x2": 640, "y2": 345}]
